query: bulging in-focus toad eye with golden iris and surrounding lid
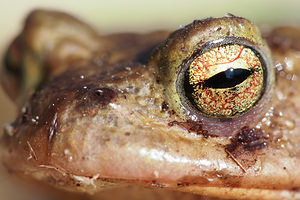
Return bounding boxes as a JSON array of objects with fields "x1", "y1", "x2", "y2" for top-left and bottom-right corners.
[{"x1": 149, "y1": 15, "x2": 275, "y2": 136}]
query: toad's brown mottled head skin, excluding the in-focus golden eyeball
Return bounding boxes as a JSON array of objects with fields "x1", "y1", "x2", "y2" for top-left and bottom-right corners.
[{"x1": 2, "y1": 11, "x2": 300, "y2": 199}]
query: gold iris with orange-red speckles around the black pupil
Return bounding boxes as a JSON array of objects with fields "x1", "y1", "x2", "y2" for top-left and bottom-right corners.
[{"x1": 188, "y1": 44, "x2": 264, "y2": 118}]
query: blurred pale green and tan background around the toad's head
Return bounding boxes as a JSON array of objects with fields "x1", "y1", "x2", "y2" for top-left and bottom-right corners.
[{"x1": 0, "y1": 0, "x2": 300, "y2": 200}]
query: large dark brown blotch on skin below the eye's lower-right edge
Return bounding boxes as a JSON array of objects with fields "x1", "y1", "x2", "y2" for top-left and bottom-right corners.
[{"x1": 225, "y1": 127, "x2": 267, "y2": 172}]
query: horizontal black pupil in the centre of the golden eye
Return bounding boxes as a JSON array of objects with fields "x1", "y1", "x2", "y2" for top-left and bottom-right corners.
[{"x1": 203, "y1": 68, "x2": 251, "y2": 89}]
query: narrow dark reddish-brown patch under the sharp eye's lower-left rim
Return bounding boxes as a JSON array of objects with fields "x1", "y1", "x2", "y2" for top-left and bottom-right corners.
[{"x1": 168, "y1": 120, "x2": 208, "y2": 136}]
